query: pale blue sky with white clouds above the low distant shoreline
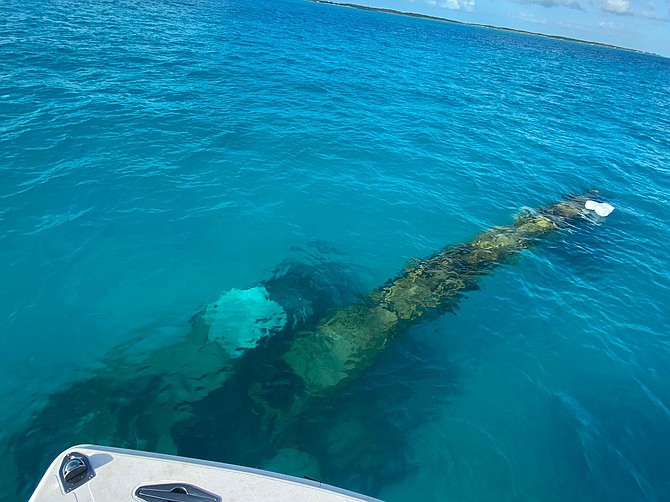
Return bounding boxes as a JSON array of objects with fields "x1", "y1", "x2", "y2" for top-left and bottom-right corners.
[{"x1": 342, "y1": 0, "x2": 670, "y2": 57}]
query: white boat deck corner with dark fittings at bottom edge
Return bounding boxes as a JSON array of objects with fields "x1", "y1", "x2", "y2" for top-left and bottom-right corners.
[{"x1": 30, "y1": 445, "x2": 375, "y2": 502}]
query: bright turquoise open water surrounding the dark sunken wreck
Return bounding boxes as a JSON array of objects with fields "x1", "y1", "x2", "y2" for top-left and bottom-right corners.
[{"x1": 0, "y1": 0, "x2": 670, "y2": 501}]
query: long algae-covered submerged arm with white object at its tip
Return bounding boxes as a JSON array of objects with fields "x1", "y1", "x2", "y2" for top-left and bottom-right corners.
[{"x1": 284, "y1": 192, "x2": 613, "y2": 395}]
